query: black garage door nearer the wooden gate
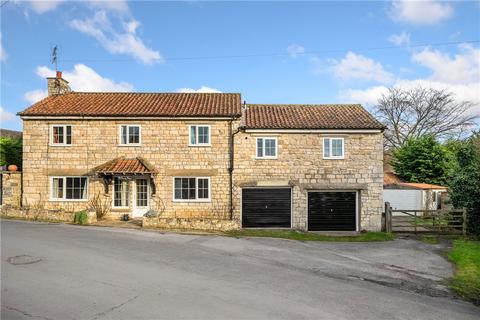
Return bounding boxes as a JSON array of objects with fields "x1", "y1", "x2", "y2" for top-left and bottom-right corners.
[{"x1": 308, "y1": 192, "x2": 357, "y2": 231}]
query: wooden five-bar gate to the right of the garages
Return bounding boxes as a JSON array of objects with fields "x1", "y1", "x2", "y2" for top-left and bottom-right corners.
[{"x1": 383, "y1": 202, "x2": 467, "y2": 235}]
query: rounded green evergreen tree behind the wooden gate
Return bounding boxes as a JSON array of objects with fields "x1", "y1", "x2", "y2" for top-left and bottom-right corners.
[{"x1": 392, "y1": 136, "x2": 450, "y2": 185}]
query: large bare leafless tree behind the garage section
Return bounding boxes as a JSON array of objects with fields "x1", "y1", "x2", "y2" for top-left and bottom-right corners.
[{"x1": 374, "y1": 87, "x2": 478, "y2": 148}]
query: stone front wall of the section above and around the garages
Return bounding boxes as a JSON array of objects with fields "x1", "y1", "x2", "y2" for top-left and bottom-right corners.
[{"x1": 234, "y1": 133, "x2": 383, "y2": 230}]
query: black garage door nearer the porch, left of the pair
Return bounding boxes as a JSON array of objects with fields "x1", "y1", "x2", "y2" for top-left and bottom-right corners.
[{"x1": 242, "y1": 188, "x2": 292, "y2": 228}]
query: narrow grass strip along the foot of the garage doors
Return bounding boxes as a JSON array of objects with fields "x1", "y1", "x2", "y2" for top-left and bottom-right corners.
[{"x1": 225, "y1": 229, "x2": 395, "y2": 242}]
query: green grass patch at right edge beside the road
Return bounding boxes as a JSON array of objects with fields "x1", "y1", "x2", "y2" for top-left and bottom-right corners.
[{"x1": 448, "y1": 240, "x2": 480, "y2": 305}]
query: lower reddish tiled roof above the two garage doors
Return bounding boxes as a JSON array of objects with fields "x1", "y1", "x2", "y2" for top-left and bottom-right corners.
[{"x1": 245, "y1": 104, "x2": 384, "y2": 130}]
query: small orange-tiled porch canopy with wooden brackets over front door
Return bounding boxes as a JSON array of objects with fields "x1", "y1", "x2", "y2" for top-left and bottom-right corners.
[{"x1": 92, "y1": 157, "x2": 157, "y2": 194}]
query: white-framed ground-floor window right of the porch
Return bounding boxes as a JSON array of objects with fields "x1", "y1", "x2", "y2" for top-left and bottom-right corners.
[{"x1": 173, "y1": 177, "x2": 211, "y2": 202}]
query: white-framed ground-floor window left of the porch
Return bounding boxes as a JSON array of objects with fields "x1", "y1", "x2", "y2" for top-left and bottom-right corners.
[{"x1": 50, "y1": 177, "x2": 88, "y2": 201}]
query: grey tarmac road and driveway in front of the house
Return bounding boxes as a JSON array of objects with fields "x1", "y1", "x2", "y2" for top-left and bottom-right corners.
[{"x1": 1, "y1": 220, "x2": 480, "y2": 320}]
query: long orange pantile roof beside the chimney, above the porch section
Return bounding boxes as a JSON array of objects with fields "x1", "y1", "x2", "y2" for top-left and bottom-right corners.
[{"x1": 19, "y1": 92, "x2": 241, "y2": 117}]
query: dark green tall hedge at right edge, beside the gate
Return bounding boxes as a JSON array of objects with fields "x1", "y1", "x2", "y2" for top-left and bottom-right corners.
[{"x1": 449, "y1": 133, "x2": 480, "y2": 235}]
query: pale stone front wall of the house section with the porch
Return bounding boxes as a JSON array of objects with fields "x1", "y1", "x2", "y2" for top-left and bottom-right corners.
[{"x1": 23, "y1": 119, "x2": 238, "y2": 219}]
